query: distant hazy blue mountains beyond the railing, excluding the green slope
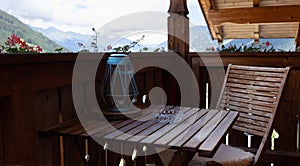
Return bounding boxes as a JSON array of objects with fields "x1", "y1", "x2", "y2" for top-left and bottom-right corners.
[{"x1": 29, "y1": 23, "x2": 295, "y2": 52}]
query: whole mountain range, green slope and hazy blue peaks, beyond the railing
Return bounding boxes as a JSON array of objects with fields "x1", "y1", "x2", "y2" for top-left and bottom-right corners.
[{"x1": 0, "y1": 10, "x2": 295, "y2": 52}]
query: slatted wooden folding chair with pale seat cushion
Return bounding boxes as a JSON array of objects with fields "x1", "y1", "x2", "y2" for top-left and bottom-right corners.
[{"x1": 189, "y1": 64, "x2": 290, "y2": 165}]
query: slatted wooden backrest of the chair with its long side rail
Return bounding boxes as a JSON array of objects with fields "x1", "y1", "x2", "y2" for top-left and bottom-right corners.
[{"x1": 217, "y1": 65, "x2": 290, "y2": 164}]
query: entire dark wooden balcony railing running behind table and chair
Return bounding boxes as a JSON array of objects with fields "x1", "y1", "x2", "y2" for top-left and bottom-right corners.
[{"x1": 0, "y1": 53, "x2": 300, "y2": 165}]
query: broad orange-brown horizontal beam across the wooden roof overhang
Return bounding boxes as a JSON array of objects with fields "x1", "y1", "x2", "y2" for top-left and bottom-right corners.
[{"x1": 208, "y1": 5, "x2": 300, "y2": 25}]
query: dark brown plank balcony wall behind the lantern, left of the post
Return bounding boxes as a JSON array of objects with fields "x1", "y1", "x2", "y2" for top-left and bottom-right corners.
[{"x1": 0, "y1": 54, "x2": 166, "y2": 165}]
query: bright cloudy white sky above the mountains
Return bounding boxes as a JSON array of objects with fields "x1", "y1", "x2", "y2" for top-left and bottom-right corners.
[{"x1": 0, "y1": 0, "x2": 205, "y2": 34}]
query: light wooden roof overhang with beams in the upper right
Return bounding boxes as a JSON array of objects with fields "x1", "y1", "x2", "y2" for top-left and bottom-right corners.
[{"x1": 198, "y1": 0, "x2": 300, "y2": 45}]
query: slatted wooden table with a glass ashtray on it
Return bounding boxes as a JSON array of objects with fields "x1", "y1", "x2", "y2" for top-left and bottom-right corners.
[{"x1": 42, "y1": 106, "x2": 238, "y2": 165}]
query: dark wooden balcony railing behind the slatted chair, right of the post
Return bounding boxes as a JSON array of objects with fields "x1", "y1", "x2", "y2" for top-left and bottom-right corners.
[{"x1": 190, "y1": 53, "x2": 300, "y2": 165}]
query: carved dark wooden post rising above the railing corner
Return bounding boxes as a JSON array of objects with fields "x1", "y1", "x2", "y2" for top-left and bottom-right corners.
[{"x1": 168, "y1": 0, "x2": 190, "y2": 64}]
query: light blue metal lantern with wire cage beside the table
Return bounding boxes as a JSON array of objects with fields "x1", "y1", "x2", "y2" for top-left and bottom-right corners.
[{"x1": 101, "y1": 54, "x2": 138, "y2": 112}]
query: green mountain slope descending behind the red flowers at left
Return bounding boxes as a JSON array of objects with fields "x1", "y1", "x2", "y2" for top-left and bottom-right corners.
[{"x1": 0, "y1": 10, "x2": 68, "y2": 52}]
